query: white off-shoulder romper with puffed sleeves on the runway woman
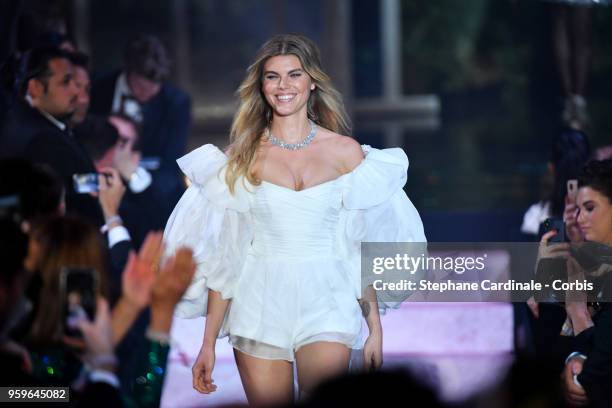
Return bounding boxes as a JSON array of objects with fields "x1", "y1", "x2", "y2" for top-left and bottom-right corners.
[{"x1": 164, "y1": 144, "x2": 426, "y2": 361}]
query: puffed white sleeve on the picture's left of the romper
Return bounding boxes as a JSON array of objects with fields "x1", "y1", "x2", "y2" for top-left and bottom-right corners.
[{"x1": 164, "y1": 144, "x2": 252, "y2": 318}]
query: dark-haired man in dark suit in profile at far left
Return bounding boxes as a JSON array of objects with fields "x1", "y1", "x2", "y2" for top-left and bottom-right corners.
[{"x1": 0, "y1": 48, "x2": 104, "y2": 225}]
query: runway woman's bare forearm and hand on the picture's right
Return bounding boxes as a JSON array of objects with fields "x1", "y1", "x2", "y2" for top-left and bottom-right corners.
[{"x1": 359, "y1": 285, "x2": 383, "y2": 371}]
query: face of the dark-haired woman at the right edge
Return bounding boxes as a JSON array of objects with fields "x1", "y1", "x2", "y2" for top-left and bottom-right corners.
[{"x1": 576, "y1": 187, "x2": 612, "y2": 245}]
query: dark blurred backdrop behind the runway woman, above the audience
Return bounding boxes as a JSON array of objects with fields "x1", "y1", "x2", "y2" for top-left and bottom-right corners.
[{"x1": 32, "y1": 0, "x2": 612, "y2": 240}]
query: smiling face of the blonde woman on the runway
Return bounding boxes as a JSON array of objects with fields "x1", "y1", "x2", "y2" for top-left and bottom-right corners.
[{"x1": 262, "y1": 55, "x2": 315, "y2": 116}]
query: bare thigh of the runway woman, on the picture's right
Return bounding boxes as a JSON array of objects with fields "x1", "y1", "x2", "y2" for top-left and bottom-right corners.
[{"x1": 295, "y1": 341, "x2": 351, "y2": 398}]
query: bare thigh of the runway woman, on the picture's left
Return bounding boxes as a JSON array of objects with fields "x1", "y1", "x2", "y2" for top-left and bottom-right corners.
[{"x1": 234, "y1": 349, "x2": 293, "y2": 406}]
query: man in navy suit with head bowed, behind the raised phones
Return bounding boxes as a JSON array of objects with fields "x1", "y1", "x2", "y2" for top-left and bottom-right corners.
[{"x1": 90, "y1": 36, "x2": 191, "y2": 219}]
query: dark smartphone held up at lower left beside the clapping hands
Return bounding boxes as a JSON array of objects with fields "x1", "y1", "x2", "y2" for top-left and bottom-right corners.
[{"x1": 60, "y1": 268, "x2": 100, "y2": 337}]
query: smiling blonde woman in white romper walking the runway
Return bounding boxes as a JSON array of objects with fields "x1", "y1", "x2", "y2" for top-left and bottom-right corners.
[{"x1": 165, "y1": 35, "x2": 425, "y2": 405}]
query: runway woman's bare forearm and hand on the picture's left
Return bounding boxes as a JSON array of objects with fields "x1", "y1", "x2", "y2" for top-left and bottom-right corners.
[{"x1": 191, "y1": 289, "x2": 230, "y2": 394}]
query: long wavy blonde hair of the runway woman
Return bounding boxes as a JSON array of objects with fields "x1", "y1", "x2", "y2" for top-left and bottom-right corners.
[{"x1": 225, "y1": 34, "x2": 350, "y2": 193}]
